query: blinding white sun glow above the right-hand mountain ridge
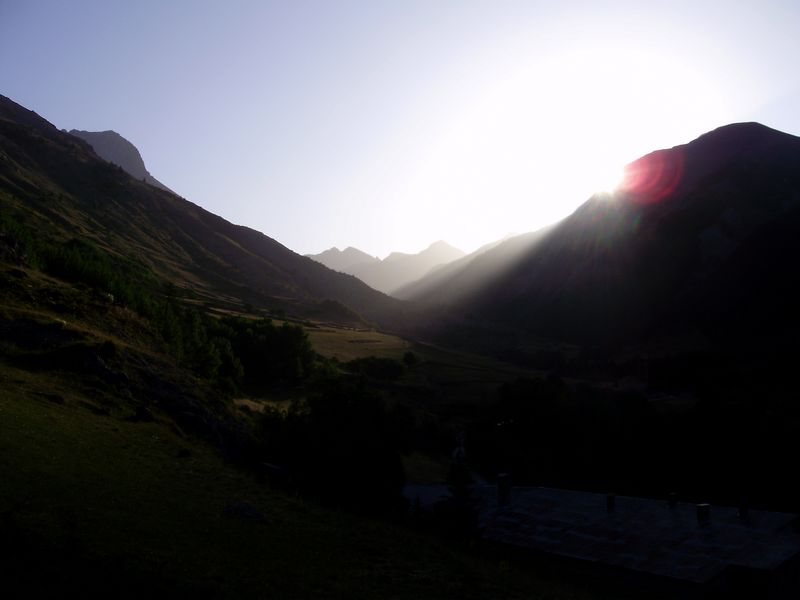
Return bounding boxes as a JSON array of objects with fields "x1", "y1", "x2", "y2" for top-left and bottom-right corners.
[{"x1": 351, "y1": 39, "x2": 748, "y2": 248}]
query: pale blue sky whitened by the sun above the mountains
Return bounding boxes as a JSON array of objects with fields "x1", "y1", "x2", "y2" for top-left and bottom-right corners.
[{"x1": 0, "y1": 0, "x2": 800, "y2": 257}]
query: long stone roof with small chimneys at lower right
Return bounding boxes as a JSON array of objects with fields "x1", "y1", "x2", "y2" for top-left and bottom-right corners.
[{"x1": 473, "y1": 486, "x2": 800, "y2": 583}]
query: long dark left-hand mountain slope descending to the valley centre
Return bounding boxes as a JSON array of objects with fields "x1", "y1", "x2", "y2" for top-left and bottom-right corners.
[{"x1": 0, "y1": 96, "x2": 401, "y2": 325}]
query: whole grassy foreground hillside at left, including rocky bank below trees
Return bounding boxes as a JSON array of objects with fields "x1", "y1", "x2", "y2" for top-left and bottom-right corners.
[{"x1": 0, "y1": 247, "x2": 599, "y2": 599}]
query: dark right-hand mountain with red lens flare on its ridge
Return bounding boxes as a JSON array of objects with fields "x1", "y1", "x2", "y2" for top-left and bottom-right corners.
[{"x1": 410, "y1": 123, "x2": 800, "y2": 360}]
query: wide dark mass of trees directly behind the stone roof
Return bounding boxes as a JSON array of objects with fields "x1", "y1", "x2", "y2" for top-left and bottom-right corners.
[{"x1": 467, "y1": 376, "x2": 800, "y2": 511}]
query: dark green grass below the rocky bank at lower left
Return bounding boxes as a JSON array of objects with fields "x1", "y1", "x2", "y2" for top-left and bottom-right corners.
[{"x1": 0, "y1": 363, "x2": 612, "y2": 599}]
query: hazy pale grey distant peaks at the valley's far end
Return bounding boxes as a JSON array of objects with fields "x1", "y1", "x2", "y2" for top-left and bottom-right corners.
[{"x1": 309, "y1": 241, "x2": 464, "y2": 295}]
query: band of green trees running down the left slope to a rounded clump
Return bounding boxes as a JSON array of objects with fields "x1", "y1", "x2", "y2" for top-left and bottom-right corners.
[{"x1": 0, "y1": 215, "x2": 314, "y2": 391}]
